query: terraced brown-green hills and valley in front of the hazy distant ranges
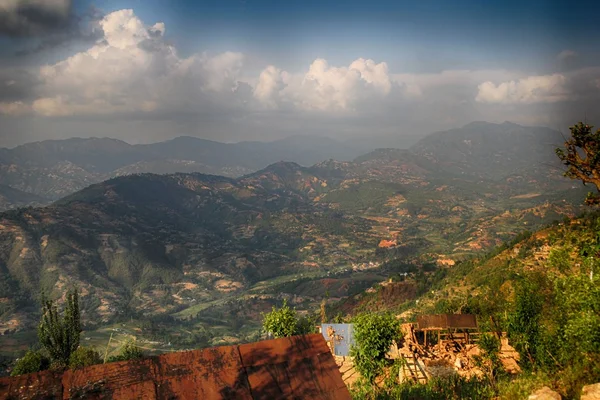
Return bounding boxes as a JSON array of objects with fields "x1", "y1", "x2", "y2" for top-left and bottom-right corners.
[{"x1": 0, "y1": 150, "x2": 577, "y2": 346}]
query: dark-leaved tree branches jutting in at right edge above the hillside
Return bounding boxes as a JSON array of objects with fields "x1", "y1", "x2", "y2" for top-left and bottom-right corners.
[{"x1": 556, "y1": 122, "x2": 600, "y2": 205}]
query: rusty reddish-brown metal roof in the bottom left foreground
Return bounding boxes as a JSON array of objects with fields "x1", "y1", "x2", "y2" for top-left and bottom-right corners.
[{"x1": 0, "y1": 334, "x2": 350, "y2": 400}]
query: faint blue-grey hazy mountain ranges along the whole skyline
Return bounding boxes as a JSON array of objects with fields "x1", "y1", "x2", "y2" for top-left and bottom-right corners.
[{"x1": 0, "y1": 122, "x2": 562, "y2": 210}]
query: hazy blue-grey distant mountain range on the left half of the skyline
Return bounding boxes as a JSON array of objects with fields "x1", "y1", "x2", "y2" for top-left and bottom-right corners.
[{"x1": 0, "y1": 135, "x2": 361, "y2": 210}]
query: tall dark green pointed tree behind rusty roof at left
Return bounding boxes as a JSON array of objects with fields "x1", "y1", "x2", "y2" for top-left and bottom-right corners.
[{"x1": 38, "y1": 290, "x2": 81, "y2": 366}]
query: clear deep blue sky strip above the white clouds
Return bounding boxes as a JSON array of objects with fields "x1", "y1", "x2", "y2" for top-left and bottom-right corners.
[{"x1": 90, "y1": 0, "x2": 600, "y2": 72}]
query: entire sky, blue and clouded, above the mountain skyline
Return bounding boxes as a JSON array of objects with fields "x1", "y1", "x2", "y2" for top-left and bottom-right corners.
[{"x1": 0, "y1": 0, "x2": 600, "y2": 147}]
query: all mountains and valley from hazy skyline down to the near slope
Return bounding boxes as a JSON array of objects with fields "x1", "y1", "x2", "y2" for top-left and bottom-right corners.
[{"x1": 0, "y1": 123, "x2": 582, "y2": 344}]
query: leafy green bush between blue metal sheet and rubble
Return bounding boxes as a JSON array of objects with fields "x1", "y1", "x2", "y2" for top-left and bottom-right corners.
[{"x1": 351, "y1": 313, "x2": 400, "y2": 383}]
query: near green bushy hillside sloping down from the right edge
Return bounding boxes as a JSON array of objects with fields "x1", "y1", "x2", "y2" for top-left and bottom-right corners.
[{"x1": 327, "y1": 211, "x2": 600, "y2": 399}]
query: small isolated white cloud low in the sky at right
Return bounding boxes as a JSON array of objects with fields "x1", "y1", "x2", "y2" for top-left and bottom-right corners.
[{"x1": 475, "y1": 74, "x2": 573, "y2": 104}]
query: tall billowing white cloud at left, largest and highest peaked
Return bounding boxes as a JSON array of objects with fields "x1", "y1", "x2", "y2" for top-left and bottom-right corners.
[{"x1": 2, "y1": 10, "x2": 253, "y2": 117}]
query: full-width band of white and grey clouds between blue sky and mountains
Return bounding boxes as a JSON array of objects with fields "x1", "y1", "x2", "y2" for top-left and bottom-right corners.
[{"x1": 0, "y1": 7, "x2": 600, "y2": 144}]
